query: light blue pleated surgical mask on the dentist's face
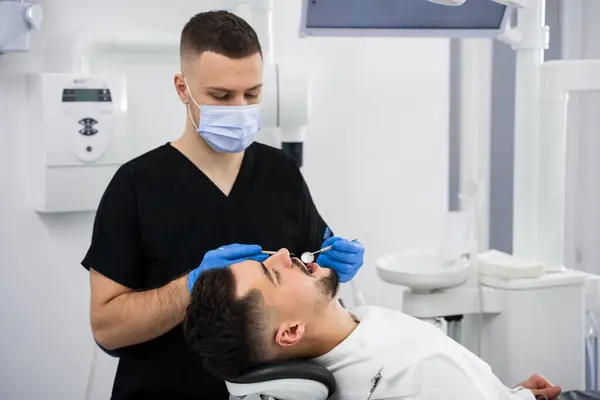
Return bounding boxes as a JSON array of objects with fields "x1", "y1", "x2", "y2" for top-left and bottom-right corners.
[{"x1": 185, "y1": 80, "x2": 262, "y2": 153}]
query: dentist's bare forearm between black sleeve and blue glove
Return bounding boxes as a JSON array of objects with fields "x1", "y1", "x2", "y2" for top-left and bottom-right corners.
[{"x1": 91, "y1": 276, "x2": 190, "y2": 350}]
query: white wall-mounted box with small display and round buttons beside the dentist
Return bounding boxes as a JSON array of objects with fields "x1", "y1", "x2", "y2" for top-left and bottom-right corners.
[{"x1": 30, "y1": 74, "x2": 131, "y2": 212}]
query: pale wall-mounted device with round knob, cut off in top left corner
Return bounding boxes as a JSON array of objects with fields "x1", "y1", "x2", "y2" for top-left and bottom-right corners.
[{"x1": 0, "y1": 0, "x2": 42, "y2": 54}]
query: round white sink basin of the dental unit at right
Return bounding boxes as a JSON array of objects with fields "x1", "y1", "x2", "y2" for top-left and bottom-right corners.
[{"x1": 375, "y1": 250, "x2": 471, "y2": 291}]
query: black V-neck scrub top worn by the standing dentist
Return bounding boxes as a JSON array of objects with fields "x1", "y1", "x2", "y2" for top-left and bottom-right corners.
[{"x1": 82, "y1": 143, "x2": 331, "y2": 400}]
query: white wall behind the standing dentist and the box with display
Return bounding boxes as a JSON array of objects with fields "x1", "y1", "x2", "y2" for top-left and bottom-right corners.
[{"x1": 0, "y1": 0, "x2": 449, "y2": 400}]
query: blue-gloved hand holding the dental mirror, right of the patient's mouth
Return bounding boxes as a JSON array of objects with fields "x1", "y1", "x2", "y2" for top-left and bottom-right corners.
[{"x1": 317, "y1": 236, "x2": 365, "y2": 283}]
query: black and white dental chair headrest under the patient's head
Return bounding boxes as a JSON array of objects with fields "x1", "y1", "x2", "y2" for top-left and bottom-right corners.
[{"x1": 96, "y1": 343, "x2": 336, "y2": 400}]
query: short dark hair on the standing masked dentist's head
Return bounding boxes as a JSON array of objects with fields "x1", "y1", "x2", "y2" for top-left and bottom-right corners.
[{"x1": 180, "y1": 11, "x2": 262, "y2": 59}]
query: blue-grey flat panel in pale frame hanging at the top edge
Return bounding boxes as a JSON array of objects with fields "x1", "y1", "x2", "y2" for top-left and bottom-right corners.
[{"x1": 300, "y1": 0, "x2": 527, "y2": 38}]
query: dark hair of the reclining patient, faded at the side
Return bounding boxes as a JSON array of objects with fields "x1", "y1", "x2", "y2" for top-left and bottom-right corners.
[{"x1": 183, "y1": 268, "x2": 269, "y2": 379}]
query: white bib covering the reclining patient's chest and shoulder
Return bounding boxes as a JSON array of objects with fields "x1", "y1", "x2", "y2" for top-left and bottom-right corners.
[{"x1": 314, "y1": 307, "x2": 510, "y2": 400}]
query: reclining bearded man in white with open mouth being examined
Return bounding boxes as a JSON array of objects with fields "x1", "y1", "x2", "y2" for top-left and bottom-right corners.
[{"x1": 184, "y1": 250, "x2": 561, "y2": 400}]
